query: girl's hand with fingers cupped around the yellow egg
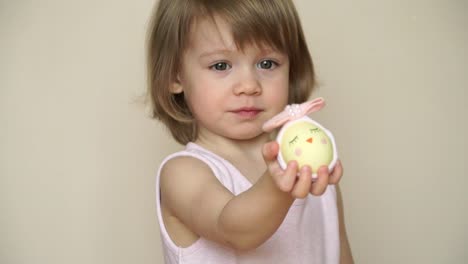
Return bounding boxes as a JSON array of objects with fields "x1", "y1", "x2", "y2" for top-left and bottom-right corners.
[{"x1": 263, "y1": 141, "x2": 343, "y2": 198}]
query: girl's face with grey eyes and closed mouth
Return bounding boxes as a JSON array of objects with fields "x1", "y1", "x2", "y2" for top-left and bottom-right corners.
[{"x1": 172, "y1": 18, "x2": 289, "y2": 140}]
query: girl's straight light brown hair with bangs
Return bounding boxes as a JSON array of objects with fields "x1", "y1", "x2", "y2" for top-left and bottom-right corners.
[{"x1": 147, "y1": 0, "x2": 315, "y2": 145}]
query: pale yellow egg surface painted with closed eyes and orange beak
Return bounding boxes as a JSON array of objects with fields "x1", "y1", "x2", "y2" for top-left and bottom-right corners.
[{"x1": 280, "y1": 121, "x2": 333, "y2": 173}]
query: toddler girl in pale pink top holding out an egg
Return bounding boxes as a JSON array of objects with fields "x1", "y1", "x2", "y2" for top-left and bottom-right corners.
[{"x1": 148, "y1": 0, "x2": 352, "y2": 264}]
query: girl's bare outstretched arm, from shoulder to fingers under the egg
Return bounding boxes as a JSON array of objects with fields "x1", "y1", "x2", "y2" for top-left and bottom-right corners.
[{"x1": 160, "y1": 144, "x2": 322, "y2": 250}]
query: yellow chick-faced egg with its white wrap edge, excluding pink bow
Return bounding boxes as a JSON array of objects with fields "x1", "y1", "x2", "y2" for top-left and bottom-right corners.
[{"x1": 276, "y1": 116, "x2": 338, "y2": 177}]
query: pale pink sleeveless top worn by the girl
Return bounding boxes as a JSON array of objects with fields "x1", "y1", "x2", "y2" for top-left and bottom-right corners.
[{"x1": 156, "y1": 143, "x2": 340, "y2": 264}]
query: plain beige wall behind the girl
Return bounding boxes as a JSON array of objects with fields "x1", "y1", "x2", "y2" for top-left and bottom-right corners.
[{"x1": 0, "y1": 0, "x2": 468, "y2": 264}]
